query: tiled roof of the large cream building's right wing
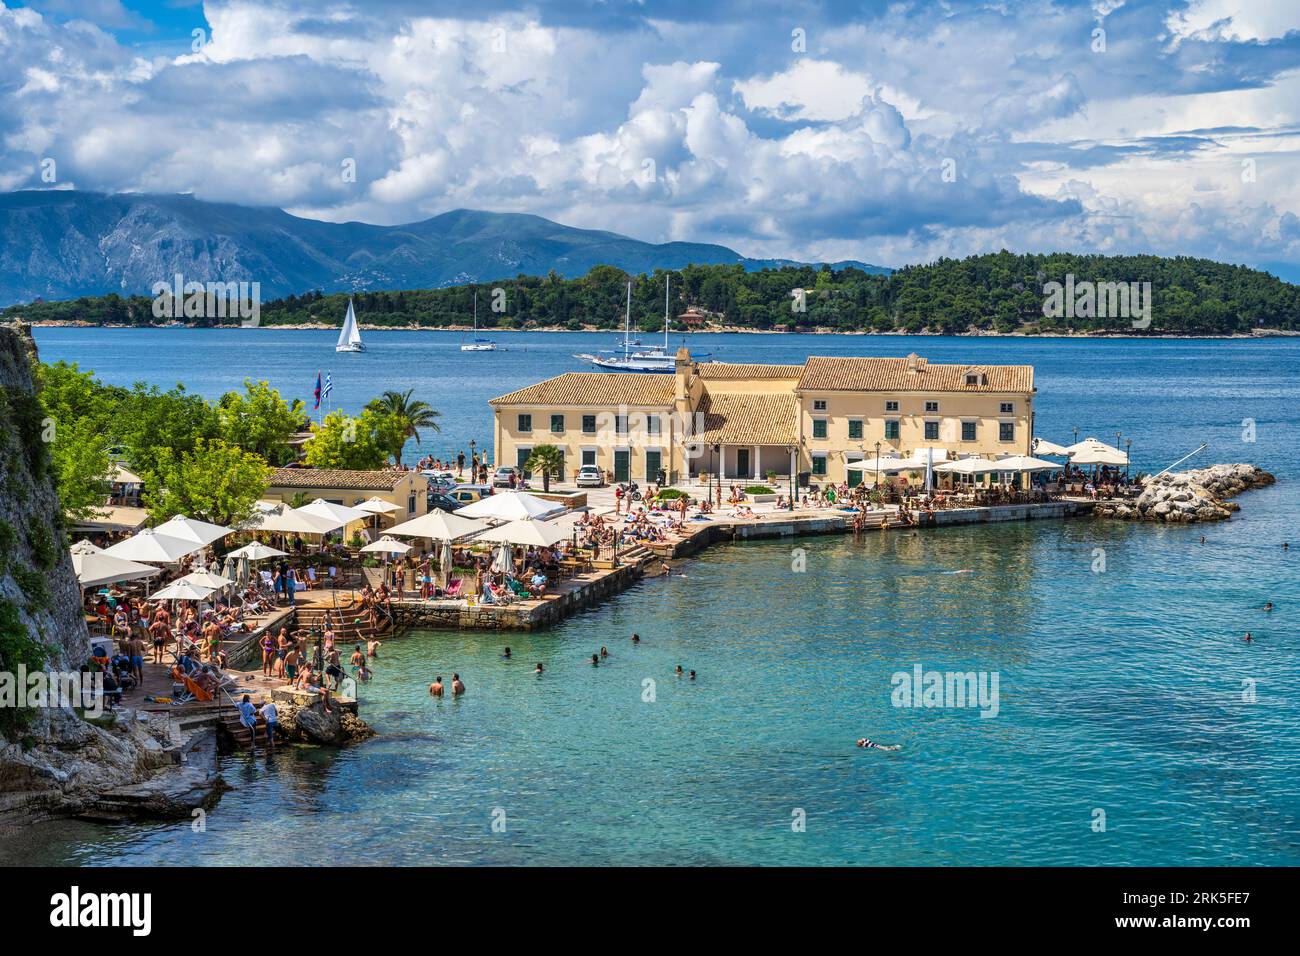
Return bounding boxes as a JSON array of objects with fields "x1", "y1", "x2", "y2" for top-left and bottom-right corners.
[{"x1": 798, "y1": 355, "x2": 1034, "y2": 392}]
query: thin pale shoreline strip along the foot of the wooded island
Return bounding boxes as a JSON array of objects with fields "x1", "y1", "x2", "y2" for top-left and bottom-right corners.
[{"x1": 20, "y1": 319, "x2": 1300, "y2": 339}]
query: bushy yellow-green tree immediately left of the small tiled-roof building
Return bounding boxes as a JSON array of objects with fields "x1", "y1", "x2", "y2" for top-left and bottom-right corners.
[{"x1": 144, "y1": 438, "x2": 270, "y2": 525}]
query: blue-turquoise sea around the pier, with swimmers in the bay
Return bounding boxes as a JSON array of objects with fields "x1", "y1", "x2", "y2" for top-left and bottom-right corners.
[{"x1": 12, "y1": 329, "x2": 1300, "y2": 865}]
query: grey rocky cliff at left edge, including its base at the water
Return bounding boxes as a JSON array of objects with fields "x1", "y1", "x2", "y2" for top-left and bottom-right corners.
[{"x1": 0, "y1": 325, "x2": 193, "y2": 825}]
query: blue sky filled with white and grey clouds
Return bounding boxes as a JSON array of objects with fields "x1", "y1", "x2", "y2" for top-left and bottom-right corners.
[{"x1": 0, "y1": 0, "x2": 1300, "y2": 276}]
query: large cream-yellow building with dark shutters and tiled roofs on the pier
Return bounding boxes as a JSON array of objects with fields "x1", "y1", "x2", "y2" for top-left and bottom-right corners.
[{"x1": 489, "y1": 349, "x2": 1035, "y2": 484}]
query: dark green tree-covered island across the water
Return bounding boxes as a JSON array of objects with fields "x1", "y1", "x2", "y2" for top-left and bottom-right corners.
[{"x1": 4, "y1": 251, "x2": 1300, "y2": 336}]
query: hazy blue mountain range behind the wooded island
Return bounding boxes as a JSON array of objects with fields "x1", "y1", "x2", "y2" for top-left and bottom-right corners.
[{"x1": 0, "y1": 190, "x2": 889, "y2": 306}]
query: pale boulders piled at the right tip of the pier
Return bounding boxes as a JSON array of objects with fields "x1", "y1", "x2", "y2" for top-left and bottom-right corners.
[{"x1": 1093, "y1": 464, "x2": 1277, "y2": 523}]
